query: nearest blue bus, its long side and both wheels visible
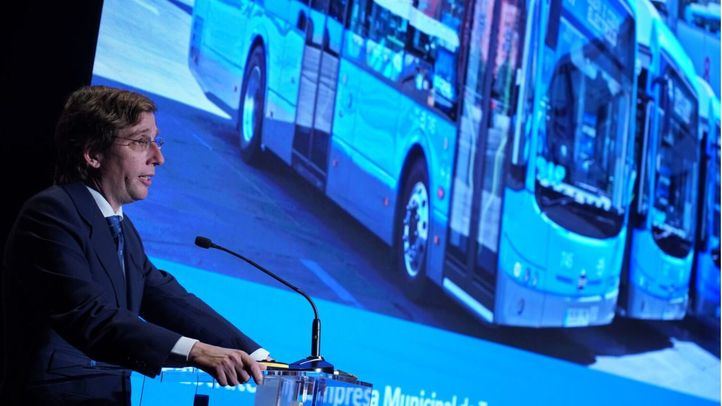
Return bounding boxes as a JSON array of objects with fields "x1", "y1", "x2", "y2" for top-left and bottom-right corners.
[{"x1": 189, "y1": 0, "x2": 636, "y2": 327}]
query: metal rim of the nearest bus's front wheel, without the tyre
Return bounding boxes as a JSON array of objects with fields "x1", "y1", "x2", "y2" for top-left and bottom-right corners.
[{"x1": 401, "y1": 182, "x2": 429, "y2": 278}]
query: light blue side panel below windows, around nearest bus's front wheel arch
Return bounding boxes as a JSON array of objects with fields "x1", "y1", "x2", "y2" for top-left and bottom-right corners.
[{"x1": 327, "y1": 59, "x2": 456, "y2": 244}]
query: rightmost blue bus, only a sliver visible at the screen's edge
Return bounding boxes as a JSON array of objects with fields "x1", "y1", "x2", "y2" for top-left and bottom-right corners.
[{"x1": 690, "y1": 77, "x2": 720, "y2": 326}]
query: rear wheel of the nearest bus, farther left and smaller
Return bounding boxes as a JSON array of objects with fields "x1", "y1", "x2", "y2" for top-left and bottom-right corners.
[{"x1": 238, "y1": 46, "x2": 266, "y2": 163}]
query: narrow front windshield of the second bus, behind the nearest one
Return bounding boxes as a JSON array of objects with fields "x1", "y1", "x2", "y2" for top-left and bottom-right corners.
[{"x1": 651, "y1": 70, "x2": 700, "y2": 257}]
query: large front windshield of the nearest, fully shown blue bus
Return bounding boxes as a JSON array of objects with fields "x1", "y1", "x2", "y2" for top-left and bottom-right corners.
[{"x1": 535, "y1": 2, "x2": 635, "y2": 238}]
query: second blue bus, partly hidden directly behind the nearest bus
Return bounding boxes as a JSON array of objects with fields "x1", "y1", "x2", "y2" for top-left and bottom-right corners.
[{"x1": 619, "y1": 1, "x2": 700, "y2": 320}]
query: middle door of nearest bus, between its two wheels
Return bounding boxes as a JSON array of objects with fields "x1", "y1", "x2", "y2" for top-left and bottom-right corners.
[{"x1": 291, "y1": 0, "x2": 346, "y2": 189}]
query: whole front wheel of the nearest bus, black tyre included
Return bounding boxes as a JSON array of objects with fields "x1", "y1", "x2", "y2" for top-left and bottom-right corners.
[{"x1": 396, "y1": 160, "x2": 431, "y2": 301}]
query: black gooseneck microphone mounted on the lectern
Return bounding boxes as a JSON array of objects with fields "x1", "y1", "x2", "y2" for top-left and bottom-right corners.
[{"x1": 196, "y1": 235, "x2": 334, "y2": 373}]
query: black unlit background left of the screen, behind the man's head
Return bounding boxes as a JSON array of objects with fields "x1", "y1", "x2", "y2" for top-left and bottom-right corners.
[{"x1": 0, "y1": 0, "x2": 103, "y2": 388}]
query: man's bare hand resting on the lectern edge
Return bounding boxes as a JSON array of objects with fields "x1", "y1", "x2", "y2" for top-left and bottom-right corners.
[{"x1": 188, "y1": 341, "x2": 266, "y2": 386}]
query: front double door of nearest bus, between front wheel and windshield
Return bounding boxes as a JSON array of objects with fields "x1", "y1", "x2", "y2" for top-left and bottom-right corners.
[{"x1": 443, "y1": 0, "x2": 526, "y2": 322}]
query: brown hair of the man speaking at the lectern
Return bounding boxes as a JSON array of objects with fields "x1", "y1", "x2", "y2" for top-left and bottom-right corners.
[{"x1": 55, "y1": 86, "x2": 156, "y2": 184}]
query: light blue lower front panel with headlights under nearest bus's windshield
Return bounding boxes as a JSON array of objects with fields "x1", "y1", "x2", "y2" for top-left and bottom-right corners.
[{"x1": 495, "y1": 190, "x2": 626, "y2": 327}]
